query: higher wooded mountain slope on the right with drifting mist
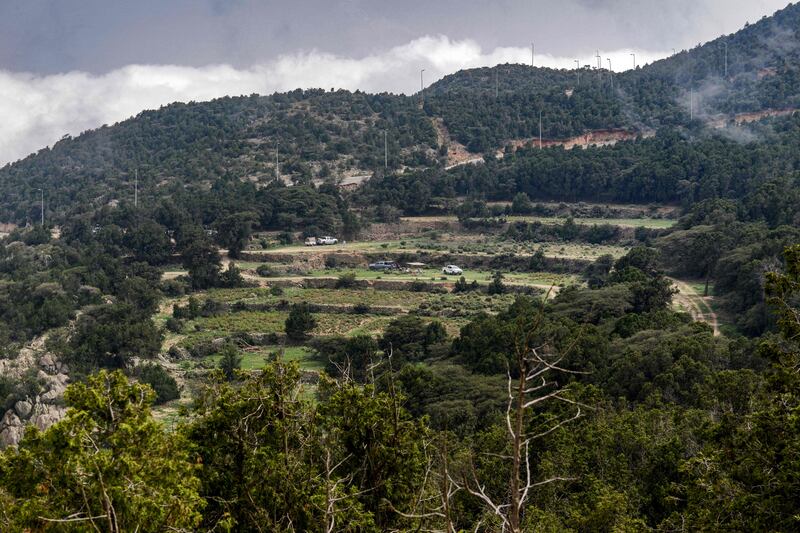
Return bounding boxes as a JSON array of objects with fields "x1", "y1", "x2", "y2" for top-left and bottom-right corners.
[{"x1": 426, "y1": 5, "x2": 800, "y2": 151}]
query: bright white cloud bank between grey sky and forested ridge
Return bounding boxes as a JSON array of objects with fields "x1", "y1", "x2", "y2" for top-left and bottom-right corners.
[{"x1": 0, "y1": 36, "x2": 666, "y2": 164}]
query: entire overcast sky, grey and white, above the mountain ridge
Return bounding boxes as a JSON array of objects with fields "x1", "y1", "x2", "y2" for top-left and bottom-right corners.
[{"x1": 0, "y1": 0, "x2": 787, "y2": 165}]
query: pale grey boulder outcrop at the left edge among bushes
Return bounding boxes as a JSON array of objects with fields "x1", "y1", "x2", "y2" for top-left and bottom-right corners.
[{"x1": 0, "y1": 343, "x2": 69, "y2": 448}]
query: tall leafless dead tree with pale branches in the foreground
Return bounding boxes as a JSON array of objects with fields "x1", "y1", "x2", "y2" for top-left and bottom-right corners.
[{"x1": 463, "y1": 300, "x2": 586, "y2": 533}]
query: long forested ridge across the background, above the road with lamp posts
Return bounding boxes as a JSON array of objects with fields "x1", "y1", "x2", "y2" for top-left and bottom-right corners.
[{"x1": 0, "y1": 1, "x2": 800, "y2": 224}]
